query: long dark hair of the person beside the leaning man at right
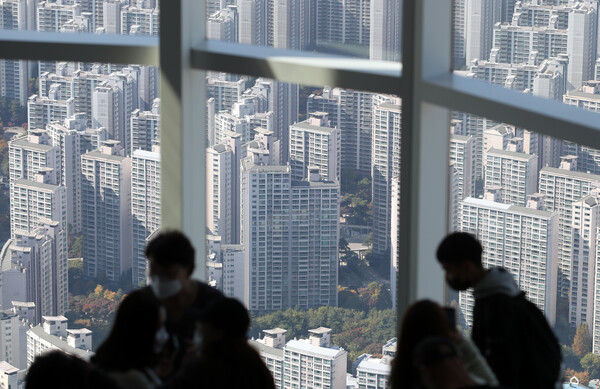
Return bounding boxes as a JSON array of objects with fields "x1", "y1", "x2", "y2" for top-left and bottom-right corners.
[{"x1": 391, "y1": 300, "x2": 451, "y2": 388}]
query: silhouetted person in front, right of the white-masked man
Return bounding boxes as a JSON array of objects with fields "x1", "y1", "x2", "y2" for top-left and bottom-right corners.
[{"x1": 165, "y1": 298, "x2": 275, "y2": 389}]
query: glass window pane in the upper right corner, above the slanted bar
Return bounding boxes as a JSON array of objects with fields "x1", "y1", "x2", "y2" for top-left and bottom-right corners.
[{"x1": 452, "y1": 0, "x2": 600, "y2": 100}]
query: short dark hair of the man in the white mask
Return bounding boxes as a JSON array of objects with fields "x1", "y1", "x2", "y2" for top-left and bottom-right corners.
[{"x1": 145, "y1": 231, "x2": 196, "y2": 274}]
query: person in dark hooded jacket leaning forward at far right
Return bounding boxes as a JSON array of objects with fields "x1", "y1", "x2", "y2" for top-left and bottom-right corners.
[{"x1": 437, "y1": 232, "x2": 561, "y2": 388}]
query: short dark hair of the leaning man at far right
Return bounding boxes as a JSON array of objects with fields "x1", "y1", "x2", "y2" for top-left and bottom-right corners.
[{"x1": 436, "y1": 232, "x2": 483, "y2": 266}]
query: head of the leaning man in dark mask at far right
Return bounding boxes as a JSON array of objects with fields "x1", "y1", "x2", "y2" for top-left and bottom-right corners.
[{"x1": 437, "y1": 232, "x2": 484, "y2": 290}]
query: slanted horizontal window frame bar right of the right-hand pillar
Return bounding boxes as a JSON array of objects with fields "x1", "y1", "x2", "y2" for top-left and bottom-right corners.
[{"x1": 420, "y1": 74, "x2": 600, "y2": 149}]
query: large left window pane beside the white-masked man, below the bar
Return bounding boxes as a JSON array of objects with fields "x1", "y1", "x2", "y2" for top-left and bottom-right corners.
[{"x1": 0, "y1": 60, "x2": 160, "y2": 369}]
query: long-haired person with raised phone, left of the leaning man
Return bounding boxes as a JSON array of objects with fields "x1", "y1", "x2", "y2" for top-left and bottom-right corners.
[{"x1": 391, "y1": 300, "x2": 498, "y2": 389}]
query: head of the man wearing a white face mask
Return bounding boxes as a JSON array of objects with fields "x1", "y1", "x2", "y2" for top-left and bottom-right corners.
[{"x1": 145, "y1": 231, "x2": 195, "y2": 300}]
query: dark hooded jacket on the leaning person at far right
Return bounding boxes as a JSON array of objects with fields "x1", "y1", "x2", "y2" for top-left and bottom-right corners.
[{"x1": 472, "y1": 268, "x2": 560, "y2": 388}]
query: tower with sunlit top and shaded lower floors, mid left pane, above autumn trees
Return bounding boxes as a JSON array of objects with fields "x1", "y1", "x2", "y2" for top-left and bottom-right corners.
[{"x1": 81, "y1": 141, "x2": 132, "y2": 281}]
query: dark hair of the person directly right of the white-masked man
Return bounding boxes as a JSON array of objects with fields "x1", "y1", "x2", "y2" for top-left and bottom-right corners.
[{"x1": 199, "y1": 297, "x2": 250, "y2": 338}]
